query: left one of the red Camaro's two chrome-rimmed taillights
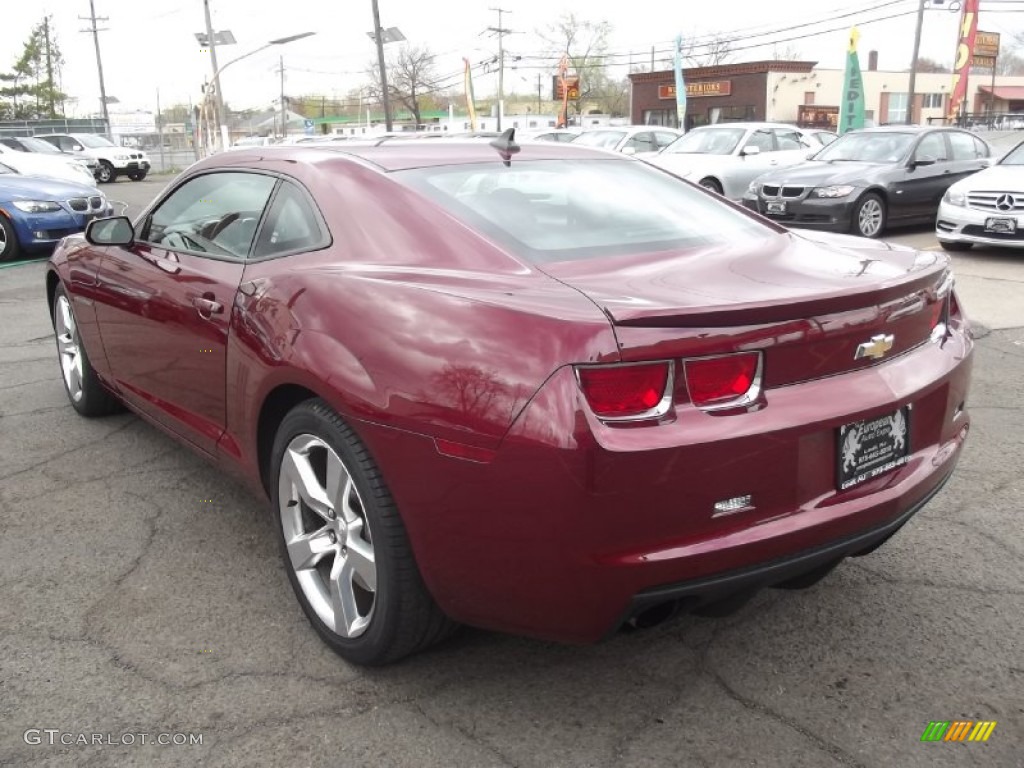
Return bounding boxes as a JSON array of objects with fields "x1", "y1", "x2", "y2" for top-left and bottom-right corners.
[{"x1": 577, "y1": 362, "x2": 670, "y2": 419}]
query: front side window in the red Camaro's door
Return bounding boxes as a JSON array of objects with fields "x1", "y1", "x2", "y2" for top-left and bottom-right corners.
[{"x1": 139, "y1": 171, "x2": 276, "y2": 259}]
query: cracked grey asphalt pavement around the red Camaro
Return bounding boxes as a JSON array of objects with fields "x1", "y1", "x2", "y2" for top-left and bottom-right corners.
[{"x1": 0, "y1": 180, "x2": 1024, "y2": 768}]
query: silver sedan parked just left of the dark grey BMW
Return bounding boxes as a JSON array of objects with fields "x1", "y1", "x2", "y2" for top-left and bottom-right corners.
[{"x1": 647, "y1": 123, "x2": 828, "y2": 200}]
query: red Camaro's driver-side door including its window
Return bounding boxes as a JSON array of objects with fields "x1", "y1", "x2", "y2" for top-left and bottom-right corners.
[{"x1": 90, "y1": 170, "x2": 278, "y2": 453}]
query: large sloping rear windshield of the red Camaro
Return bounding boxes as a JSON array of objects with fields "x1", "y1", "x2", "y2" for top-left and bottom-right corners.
[{"x1": 394, "y1": 160, "x2": 773, "y2": 263}]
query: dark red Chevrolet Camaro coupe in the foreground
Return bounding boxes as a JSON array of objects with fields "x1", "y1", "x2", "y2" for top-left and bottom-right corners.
[{"x1": 46, "y1": 133, "x2": 973, "y2": 664}]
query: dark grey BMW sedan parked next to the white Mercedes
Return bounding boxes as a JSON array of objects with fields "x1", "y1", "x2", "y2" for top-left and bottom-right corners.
[{"x1": 743, "y1": 126, "x2": 991, "y2": 238}]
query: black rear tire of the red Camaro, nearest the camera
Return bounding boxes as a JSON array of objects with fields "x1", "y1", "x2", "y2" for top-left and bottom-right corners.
[{"x1": 269, "y1": 398, "x2": 456, "y2": 666}]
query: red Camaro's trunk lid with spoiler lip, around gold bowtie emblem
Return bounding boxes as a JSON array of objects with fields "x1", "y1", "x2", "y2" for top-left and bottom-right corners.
[{"x1": 544, "y1": 232, "x2": 951, "y2": 386}]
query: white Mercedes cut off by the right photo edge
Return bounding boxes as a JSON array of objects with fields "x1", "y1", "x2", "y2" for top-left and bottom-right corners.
[{"x1": 935, "y1": 135, "x2": 1024, "y2": 251}]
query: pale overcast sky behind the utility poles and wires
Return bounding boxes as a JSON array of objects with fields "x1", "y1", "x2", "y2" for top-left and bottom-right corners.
[{"x1": 0, "y1": 0, "x2": 1024, "y2": 115}]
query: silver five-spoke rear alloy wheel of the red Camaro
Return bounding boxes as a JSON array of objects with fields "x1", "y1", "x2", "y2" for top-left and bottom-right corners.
[{"x1": 278, "y1": 434, "x2": 377, "y2": 638}]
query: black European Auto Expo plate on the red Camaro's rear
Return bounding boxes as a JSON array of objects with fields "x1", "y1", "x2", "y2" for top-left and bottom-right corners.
[{"x1": 836, "y1": 404, "x2": 911, "y2": 490}]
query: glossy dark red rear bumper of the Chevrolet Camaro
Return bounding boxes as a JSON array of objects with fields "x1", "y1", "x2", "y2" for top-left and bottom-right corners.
[{"x1": 358, "y1": 327, "x2": 972, "y2": 642}]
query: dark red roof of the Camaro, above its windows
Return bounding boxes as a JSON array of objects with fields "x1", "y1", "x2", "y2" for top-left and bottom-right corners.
[{"x1": 193, "y1": 138, "x2": 626, "y2": 171}]
